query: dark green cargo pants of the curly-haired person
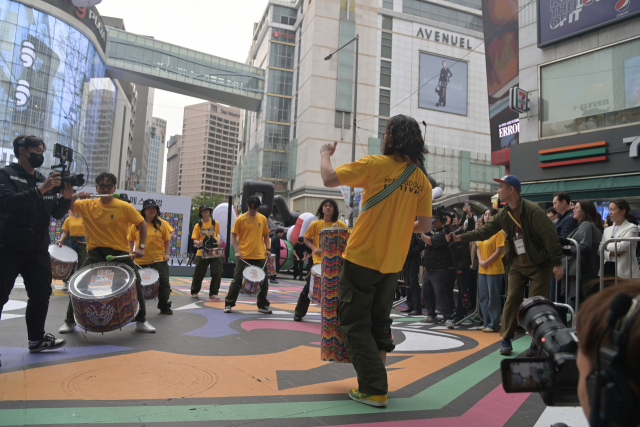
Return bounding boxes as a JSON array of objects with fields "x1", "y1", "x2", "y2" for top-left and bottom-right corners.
[{"x1": 338, "y1": 260, "x2": 398, "y2": 395}]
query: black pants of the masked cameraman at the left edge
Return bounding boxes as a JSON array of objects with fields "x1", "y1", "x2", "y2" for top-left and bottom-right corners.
[{"x1": 0, "y1": 250, "x2": 52, "y2": 341}]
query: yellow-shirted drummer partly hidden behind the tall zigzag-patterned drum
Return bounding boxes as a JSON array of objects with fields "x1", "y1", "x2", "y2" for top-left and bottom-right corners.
[{"x1": 293, "y1": 199, "x2": 347, "y2": 322}]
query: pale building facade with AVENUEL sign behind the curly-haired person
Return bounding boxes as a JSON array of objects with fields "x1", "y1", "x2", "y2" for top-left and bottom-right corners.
[{"x1": 234, "y1": 0, "x2": 504, "y2": 214}]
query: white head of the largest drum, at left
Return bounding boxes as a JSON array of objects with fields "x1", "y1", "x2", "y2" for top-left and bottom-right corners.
[{"x1": 69, "y1": 262, "x2": 136, "y2": 300}]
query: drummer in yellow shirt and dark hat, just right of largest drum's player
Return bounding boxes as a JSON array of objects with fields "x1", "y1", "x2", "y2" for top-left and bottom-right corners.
[{"x1": 128, "y1": 199, "x2": 173, "y2": 314}]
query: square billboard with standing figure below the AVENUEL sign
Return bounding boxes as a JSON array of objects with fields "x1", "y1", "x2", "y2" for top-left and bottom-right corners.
[{"x1": 418, "y1": 52, "x2": 469, "y2": 116}]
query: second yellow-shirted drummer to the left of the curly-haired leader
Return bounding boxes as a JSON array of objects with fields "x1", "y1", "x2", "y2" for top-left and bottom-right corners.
[{"x1": 224, "y1": 196, "x2": 271, "y2": 314}]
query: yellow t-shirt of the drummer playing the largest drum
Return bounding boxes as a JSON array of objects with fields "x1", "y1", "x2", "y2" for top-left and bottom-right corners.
[{"x1": 73, "y1": 199, "x2": 144, "y2": 253}]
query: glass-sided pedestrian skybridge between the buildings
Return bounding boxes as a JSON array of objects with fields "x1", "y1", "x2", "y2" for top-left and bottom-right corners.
[{"x1": 106, "y1": 27, "x2": 265, "y2": 111}]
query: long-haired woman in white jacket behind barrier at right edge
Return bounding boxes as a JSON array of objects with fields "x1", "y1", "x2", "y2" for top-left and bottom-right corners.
[{"x1": 598, "y1": 199, "x2": 640, "y2": 279}]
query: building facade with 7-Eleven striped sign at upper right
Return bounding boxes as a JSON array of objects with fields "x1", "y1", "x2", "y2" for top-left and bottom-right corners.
[{"x1": 511, "y1": 0, "x2": 640, "y2": 215}]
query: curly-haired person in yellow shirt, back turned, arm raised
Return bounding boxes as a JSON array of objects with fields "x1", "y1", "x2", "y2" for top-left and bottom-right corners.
[{"x1": 320, "y1": 115, "x2": 432, "y2": 407}]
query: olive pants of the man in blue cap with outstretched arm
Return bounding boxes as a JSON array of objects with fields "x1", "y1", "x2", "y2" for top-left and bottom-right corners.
[{"x1": 500, "y1": 264, "x2": 553, "y2": 339}]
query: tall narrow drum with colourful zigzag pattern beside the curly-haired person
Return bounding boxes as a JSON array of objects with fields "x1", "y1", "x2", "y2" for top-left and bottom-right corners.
[{"x1": 319, "y1": 227, "x2": 350, "y2": 362}]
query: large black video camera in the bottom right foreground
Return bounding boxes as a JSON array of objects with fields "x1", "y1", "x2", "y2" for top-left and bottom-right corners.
[{"x1": 500, "y1": 296, "x2": 580, "y2": 406}]
